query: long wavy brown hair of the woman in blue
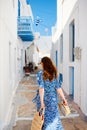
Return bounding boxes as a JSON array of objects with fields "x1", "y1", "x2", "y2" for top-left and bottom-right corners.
[{"x1": 41, "y1": 57, "x2": 57, "y2": 81}]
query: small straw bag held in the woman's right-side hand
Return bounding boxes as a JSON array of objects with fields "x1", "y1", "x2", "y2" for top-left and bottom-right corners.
[{"x1": 58, "y1": 102, "x2": 70, "y2": 116}]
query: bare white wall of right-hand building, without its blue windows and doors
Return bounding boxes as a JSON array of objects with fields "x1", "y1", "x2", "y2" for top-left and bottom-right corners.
[{"x1": 52, "y1": 0, "x2": 87, "y2": 114}]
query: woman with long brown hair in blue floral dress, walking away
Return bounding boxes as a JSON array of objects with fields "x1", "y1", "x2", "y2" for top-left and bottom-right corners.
[{"x1": 37, "y1": 57, "x2": 67, "y2": 130}]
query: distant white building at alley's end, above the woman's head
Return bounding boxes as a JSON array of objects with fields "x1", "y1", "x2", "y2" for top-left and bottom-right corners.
[{"x1": 26, "y1": 33, "x2": 52, "y2": 66}]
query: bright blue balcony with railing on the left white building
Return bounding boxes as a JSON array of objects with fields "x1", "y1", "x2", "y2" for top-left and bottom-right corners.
[{"x1": 17, "y1": 17, "x2": 34, "y2": 41}]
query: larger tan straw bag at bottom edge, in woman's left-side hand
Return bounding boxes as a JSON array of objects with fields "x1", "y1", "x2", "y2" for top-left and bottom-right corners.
[{"x1": 31, "y1": 110, "x2": 44, "y2": 130}]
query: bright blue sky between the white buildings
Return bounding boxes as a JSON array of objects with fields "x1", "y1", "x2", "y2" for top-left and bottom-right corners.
[{"x1": 27, "y1": 0, "x2": 57, "y2": 35}]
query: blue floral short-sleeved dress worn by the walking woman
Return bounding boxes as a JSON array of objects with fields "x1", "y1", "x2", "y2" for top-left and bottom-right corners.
[{"x1": 33, "y1": 71, "x2": 64, "y2": 130}]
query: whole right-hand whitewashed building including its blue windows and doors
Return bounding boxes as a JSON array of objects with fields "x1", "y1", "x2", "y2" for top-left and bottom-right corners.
[{"x1": 51, "y1": 0, "x2": 87, "y2": 115}]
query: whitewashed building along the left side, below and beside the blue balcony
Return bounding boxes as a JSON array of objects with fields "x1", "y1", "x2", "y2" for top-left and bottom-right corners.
[{"x1": 0, "y1": 0, "x2": 34, "y2": 130}]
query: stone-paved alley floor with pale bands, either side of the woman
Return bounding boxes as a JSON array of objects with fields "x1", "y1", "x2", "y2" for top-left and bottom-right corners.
[{"x1": 8, "y1": 74, "x2": 87, "y2": 130}]
